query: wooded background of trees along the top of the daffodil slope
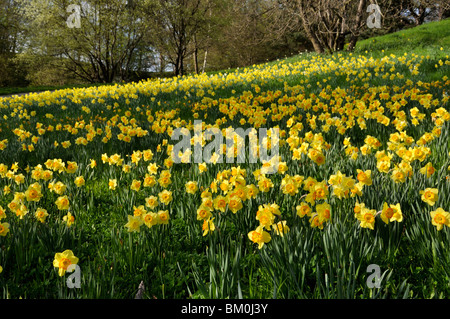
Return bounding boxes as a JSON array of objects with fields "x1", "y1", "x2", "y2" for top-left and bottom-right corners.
[{"x1": 0, "y1": 0, "x2": 450, "y2": 87}]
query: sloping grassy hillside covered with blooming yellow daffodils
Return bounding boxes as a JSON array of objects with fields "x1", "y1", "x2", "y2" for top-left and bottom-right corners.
[{"x1": 0, "y1": 21, "x2": 450, "y2": 299}]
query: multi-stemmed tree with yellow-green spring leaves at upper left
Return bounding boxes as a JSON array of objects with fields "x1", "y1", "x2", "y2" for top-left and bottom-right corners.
[{"x1": 17, "y1": 0, "x2": 156, "y2": 83}]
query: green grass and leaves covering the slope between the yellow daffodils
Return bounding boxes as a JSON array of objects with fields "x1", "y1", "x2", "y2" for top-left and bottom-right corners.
[{"x1": 0, "y1": 20, "x2": 450, "y2": 299}]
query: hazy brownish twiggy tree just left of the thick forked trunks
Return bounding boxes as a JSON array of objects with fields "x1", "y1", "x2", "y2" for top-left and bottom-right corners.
[{"x1": 202, "y1": 0, "x2": 311, "y2": 70}]
